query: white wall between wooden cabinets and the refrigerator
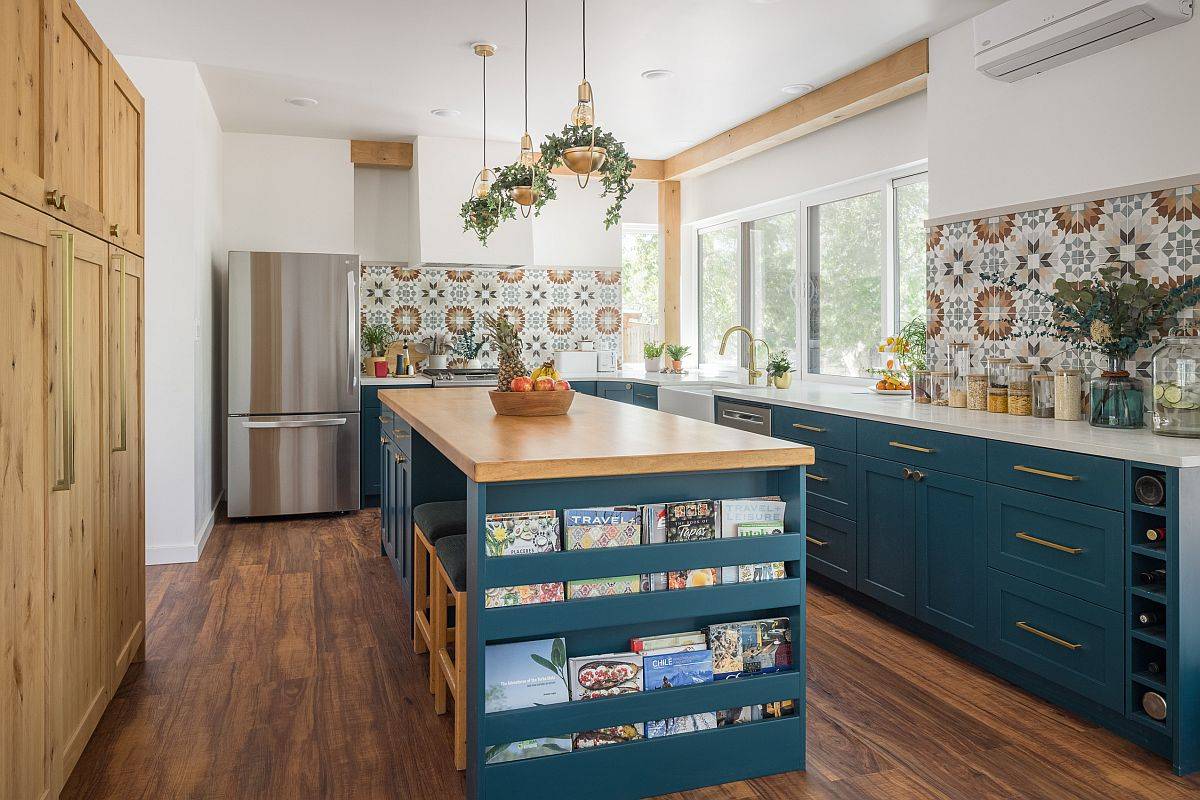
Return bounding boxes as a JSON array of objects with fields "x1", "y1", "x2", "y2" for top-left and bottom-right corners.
[{"x1": 118, "y1": 56, "x2": 223, "y2": 564}]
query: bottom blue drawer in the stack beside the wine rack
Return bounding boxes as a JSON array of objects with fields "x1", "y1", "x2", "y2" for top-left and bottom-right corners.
[{"x1": 988, "y1": 570, "x2": 1124, "y2": 711}]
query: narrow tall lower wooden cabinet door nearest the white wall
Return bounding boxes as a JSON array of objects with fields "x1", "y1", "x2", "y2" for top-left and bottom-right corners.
[{"x1": 104, "y1": 247, "x2": 145, "y2": 687}]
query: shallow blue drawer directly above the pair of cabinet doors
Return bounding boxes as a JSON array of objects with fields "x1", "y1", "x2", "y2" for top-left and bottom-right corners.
[{"x1": 858, "y1": 420, "x2": 986, "y2": 481}]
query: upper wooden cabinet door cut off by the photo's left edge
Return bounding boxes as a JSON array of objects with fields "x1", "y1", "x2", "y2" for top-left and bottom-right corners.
[{"x1": 0, "y1": 0, "x2": 52, "y2": 207}]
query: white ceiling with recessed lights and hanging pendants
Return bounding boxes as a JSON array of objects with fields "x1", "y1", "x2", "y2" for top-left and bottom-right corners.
[{"x1": 79, "y1": 0, "x2": 998, "y2": 158}]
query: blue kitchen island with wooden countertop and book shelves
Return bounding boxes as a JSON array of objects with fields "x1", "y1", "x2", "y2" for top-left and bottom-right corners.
[{"x1": 379, "y1": 389, "x2": 814, "y2": 798}]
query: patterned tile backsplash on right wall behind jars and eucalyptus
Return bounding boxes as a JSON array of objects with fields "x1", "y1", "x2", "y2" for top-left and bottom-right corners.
[{"x1": 926, "y1": 186, "x2": 1200, "y2": 377}]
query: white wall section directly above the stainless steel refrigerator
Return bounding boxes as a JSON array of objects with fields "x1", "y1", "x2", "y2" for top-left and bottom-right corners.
[{"x1": 221, "y1": 133, "x2": 354, "y2": 253}]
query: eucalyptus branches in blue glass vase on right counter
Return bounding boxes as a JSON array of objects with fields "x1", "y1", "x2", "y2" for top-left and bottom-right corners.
[{"x1": 982, "y1": 263, "x2": 1200, "y2": 428}]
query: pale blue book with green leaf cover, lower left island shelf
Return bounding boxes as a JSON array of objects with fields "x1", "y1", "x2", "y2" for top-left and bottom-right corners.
[{"x1": 484, "y1": 637, "x2": 572, "y2": 764}]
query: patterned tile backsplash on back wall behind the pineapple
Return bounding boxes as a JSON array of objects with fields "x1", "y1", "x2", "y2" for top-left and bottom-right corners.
[{"x1": 359, "y1": 264, "x2": 622, "y2": 362}]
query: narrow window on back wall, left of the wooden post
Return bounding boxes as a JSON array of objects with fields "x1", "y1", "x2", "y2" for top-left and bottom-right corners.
[{"x1": 620, "y1": 225, "x2": 662, "y2": 363}]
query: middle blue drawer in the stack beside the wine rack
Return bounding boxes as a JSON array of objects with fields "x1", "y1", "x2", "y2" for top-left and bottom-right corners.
[{"x1": 988, "y1": 485, "x2": 1124, "y2": 610}]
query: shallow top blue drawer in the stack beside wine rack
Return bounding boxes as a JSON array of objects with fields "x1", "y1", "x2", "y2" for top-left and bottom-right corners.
[{"x1": 988, "y1": 441, "x2": 1124, "y2": 510}]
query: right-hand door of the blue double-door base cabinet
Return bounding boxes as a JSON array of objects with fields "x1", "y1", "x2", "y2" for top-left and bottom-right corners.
[{"x1": 916, "y1": 473, "x2": 988, "y2": 646}]
